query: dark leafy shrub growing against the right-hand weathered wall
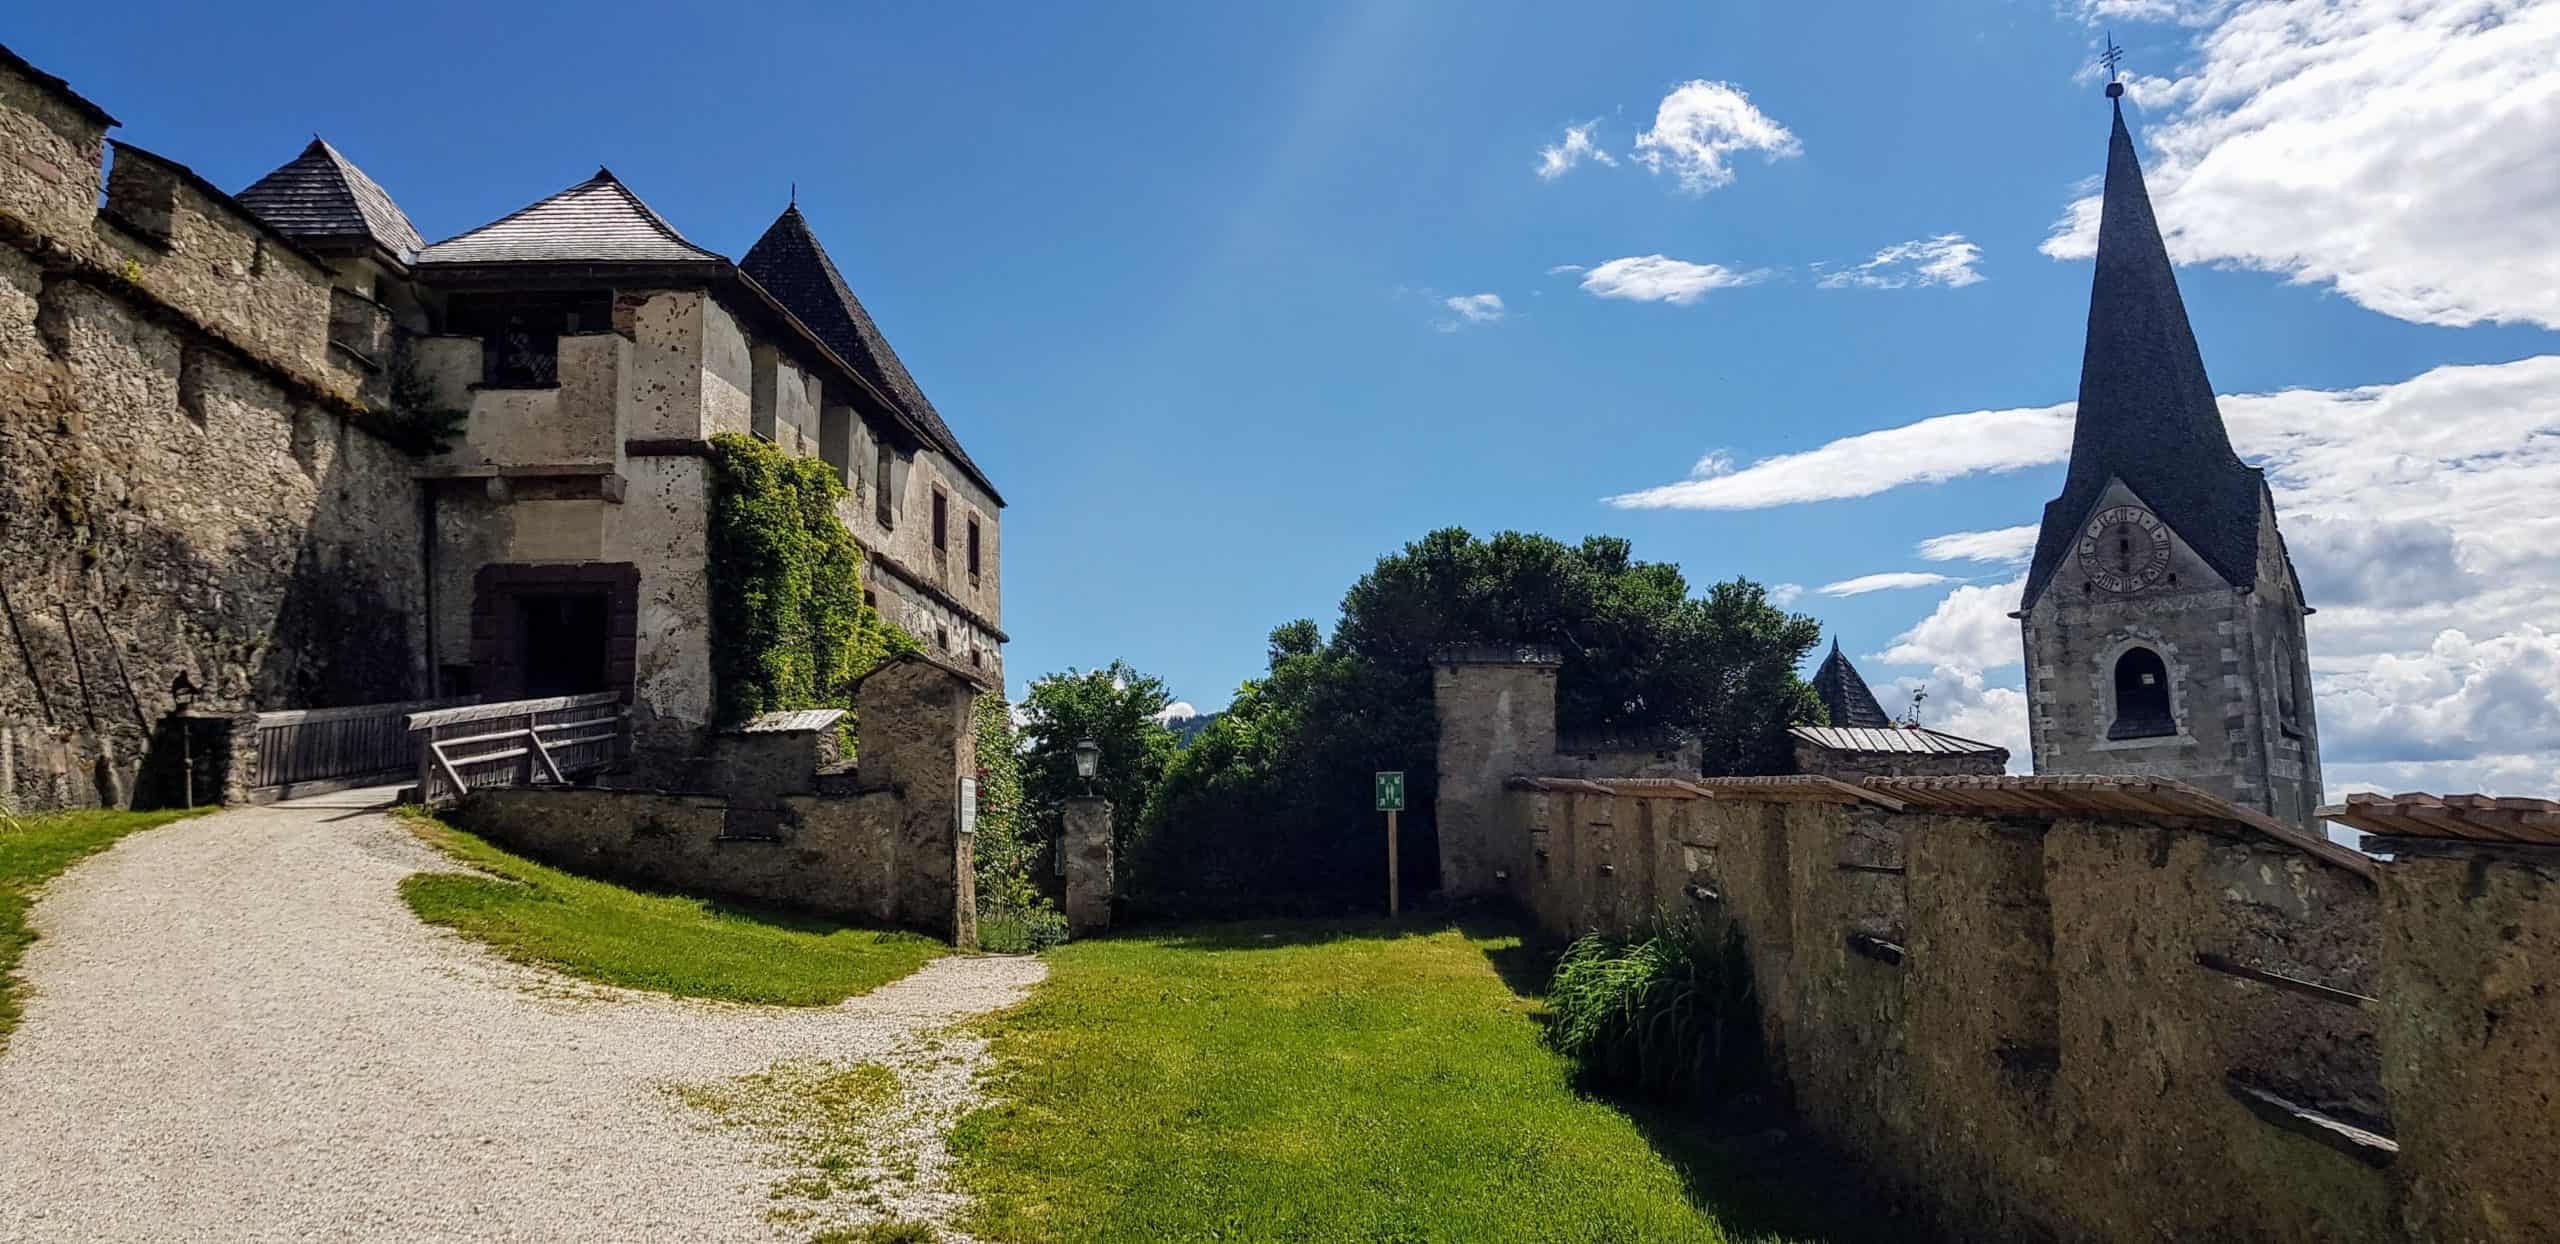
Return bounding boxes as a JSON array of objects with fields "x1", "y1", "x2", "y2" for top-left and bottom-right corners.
[{"x1": 1546, "y1": 916, "x2": 1764, "y2": 1103}]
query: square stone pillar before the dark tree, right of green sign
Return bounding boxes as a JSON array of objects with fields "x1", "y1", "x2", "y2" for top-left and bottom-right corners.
[{"x1": 1431, "y1": 645, "x2": 1564, "y2": 898}]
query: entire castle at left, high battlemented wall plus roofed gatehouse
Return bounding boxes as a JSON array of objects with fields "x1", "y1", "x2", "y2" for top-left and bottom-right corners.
[{"x1": 0, "y1": 46, "x2": 1006, "y2": 809}]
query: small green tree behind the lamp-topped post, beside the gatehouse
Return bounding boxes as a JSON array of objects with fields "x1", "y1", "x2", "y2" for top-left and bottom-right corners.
[{"x1": 1021, "y1": 660, "x2": 1175, "y2": 860}]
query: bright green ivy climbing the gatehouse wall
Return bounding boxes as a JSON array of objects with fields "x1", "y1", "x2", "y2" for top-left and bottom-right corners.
[{"x1": 712, "y1": 433, "x2": 922, "y2": 745}]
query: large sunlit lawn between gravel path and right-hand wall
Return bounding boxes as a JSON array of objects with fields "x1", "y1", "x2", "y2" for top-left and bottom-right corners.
[{"x1": 952, "y1": 921, "x2": 1894, "y2": 1244}]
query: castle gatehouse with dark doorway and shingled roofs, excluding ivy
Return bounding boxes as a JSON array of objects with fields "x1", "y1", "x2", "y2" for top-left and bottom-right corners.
[{"x1": 241, "y1": 149, "x2": 1004, "y2": 742}]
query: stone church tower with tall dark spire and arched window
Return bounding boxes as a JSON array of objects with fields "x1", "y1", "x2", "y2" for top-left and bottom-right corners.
[{"x1": 2017, "y1": 82, "x2": 2319, "y2": 824}]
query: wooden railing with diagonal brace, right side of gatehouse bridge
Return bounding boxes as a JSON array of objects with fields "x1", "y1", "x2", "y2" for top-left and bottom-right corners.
[{"x1": 410, "y1": 691, "x2": 630, "y2": 806}]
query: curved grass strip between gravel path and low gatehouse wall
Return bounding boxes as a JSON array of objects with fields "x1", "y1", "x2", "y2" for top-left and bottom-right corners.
[{"x1": 399, "y1": 814, "x2": 950, "y2": 1006}]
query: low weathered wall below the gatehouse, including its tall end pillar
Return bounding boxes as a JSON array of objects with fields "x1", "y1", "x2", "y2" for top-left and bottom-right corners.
[{"x1": 456, "y1": 658, "x2": 978, "y2": 947}]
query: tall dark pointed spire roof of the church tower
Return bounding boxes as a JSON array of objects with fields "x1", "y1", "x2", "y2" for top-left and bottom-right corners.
[{"x1": 2025, "y1": 90, "x2": 2266, "y2": 607}]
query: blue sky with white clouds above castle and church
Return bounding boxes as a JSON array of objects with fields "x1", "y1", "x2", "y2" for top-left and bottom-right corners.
[{"x1": 20, "y1": 0, "x2": 2560, "y2": 793}]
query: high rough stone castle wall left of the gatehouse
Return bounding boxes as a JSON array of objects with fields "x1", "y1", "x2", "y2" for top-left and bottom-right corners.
[{"x1": 0, "y1": 59, "x2": 425, "y2": 809}]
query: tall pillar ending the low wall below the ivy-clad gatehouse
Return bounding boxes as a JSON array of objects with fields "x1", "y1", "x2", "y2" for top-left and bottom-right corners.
[{"x1": 855, "y1": 653, "x2": 980, "y2": 950}]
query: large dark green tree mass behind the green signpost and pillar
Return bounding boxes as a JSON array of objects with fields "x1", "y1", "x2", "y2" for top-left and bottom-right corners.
[{"x1": 1129, "y1": 527, "x2": 1820, "y2": 906}]
